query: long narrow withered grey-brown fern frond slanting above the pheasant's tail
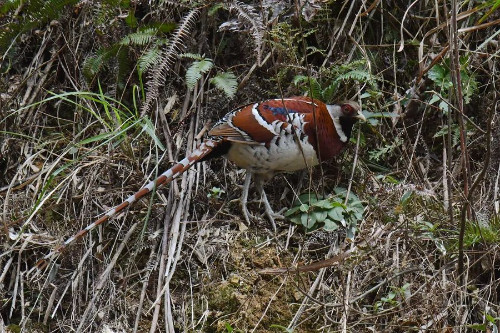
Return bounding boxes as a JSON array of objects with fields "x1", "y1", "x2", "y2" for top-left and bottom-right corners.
[{"x1": 142, "y1": 8, "x2": 200, "y2": 114}]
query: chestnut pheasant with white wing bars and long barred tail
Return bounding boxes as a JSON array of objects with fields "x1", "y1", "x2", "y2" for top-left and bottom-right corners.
[{"x1": 37, "y1": 97, "x2": 365, "y2": 266}]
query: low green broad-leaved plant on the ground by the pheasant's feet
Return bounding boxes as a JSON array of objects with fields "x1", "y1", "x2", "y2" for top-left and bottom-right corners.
[{"x1": 285, "y1": 187, "x2": 365, "y2": 239}]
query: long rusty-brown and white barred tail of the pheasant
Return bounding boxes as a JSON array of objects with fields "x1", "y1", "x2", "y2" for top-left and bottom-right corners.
[{"x1": 36, "y1": 140, "x2": 221, "y2": 269}]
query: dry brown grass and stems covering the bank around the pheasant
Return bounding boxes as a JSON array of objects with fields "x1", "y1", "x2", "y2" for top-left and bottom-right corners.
[{"x1": 0, "y1": 0, "x2": 500, "y2": 332}]
